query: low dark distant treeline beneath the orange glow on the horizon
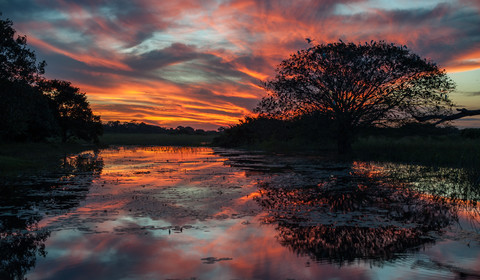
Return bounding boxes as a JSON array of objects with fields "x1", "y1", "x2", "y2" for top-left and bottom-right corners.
[{"x1": 103, "y1": 121, "x2": 218, "y2": 135}]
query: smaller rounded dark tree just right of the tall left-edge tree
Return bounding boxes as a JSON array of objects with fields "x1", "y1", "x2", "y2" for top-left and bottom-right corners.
[{"x1": 38, "y1": 80, "x2": 103, "y2": 143}]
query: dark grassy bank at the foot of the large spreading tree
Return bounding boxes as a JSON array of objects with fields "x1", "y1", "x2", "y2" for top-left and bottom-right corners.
[{"x1": 217, "y1": 135, "x2": 480, "y2": 169}]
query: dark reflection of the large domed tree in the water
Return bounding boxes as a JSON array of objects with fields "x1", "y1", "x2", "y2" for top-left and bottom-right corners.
[{"x1": 256, "y1": 162, "x2": 457, "y2": 264}]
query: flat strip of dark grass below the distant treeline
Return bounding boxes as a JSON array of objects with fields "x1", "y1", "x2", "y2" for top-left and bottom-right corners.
[{"x1": 100, "y1": 133, "x2": 215, "y2": 146}]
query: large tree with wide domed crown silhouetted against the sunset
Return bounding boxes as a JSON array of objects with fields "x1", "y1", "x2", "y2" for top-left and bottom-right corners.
[{"x1": 256, "y1": 41, "x2": 455, "y2": 153}]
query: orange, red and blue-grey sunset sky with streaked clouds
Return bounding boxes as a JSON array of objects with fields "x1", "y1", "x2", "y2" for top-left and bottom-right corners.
[{"x1": 0, "y1": 0, "x2": 480, "y2": 130}]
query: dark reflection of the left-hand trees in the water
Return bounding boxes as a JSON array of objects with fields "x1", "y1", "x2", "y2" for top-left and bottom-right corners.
[{"x1": 0, "y1": 153, "x2": 103, "y2": 279}]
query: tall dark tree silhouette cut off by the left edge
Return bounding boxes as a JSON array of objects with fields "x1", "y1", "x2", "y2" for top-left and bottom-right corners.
[{"x1": 0, "y1": 14, "x2": 56, "y2": 141}]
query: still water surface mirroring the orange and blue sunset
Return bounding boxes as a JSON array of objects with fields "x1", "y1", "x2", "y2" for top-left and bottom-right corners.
[{"x1": 0, "y1": 147, "x2": 480, "y2": 279}]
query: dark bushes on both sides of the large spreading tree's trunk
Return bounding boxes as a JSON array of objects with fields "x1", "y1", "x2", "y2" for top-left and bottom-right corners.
[{"x1": 213, "y1": 113, "x2": 464, "y2": 149}]
